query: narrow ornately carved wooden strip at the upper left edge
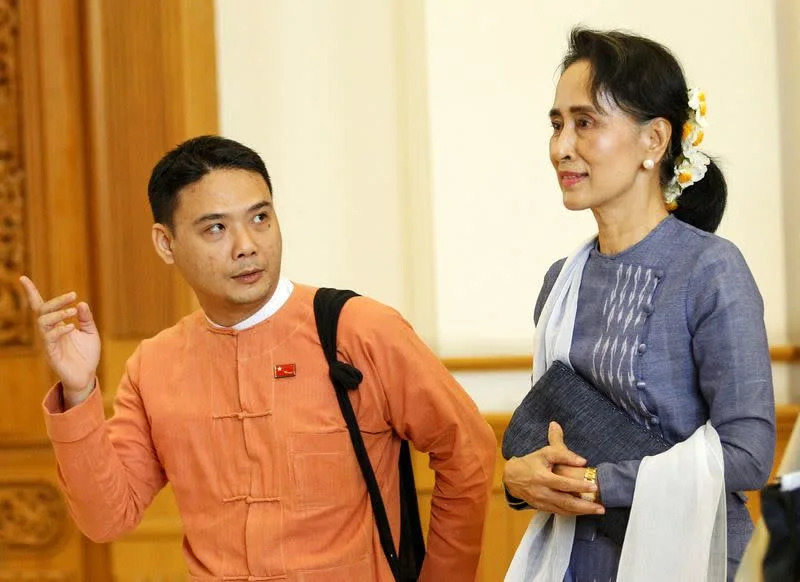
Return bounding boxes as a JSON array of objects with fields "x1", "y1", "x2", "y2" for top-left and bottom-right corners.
[{"x1": 0, "y1": 0, "x2": 31, "y2": 346}]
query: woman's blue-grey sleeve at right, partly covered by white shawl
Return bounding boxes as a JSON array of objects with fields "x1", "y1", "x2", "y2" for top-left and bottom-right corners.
[{"x1": 597, "y1": 239, "x2": 775, "y2": 507}]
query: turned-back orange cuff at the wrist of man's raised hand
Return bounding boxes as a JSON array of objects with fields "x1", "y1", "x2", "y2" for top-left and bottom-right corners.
[{"x1": 42, "y1": 381, "x2": 105, "y2": 443}]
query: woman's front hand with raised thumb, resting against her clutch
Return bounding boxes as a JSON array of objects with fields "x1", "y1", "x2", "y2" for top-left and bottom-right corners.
[{"x1": 503, "y1": 422, "x2": 605, "y2": 515}]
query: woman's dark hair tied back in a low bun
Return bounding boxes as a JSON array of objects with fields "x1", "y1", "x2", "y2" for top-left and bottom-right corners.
[{"x1": 561, "y1": 27, "x2": 727, "y2": 232}]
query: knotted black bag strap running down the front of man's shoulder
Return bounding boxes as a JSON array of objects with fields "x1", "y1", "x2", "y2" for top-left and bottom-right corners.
[{"x1": 314, "y1": 287, "x2": 400, "y2": 581}]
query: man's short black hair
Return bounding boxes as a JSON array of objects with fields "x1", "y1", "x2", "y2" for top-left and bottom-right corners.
[{"x1": 147, "y1": 135, "x2": 272, "y2": 228}]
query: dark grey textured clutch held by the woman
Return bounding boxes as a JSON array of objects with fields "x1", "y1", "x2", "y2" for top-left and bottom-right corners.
[{"x1": 503, "y1": 361, "x2": 672, "y2": 546}]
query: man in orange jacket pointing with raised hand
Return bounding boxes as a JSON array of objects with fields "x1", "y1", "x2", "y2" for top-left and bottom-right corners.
[{"x1": 22, "y1": 136, "x2": 495, "y2": 582}]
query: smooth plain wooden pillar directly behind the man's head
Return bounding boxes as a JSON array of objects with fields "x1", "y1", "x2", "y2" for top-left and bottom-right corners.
[{"x1": 86, "y1": 0, "x2": 217, "y2": 341}]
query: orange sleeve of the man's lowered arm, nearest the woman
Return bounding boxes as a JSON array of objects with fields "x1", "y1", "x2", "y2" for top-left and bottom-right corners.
[{"x1": 345, "y1": 299, "x2": 497, "y2": 581}]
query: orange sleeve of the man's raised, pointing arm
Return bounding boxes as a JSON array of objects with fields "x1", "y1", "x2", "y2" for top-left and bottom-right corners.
[{"x1": 43, "y1": 350, "x2": 166, "y2": 542}]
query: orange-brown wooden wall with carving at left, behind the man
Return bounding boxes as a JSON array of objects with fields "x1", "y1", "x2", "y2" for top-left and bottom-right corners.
[{"x1": 0, "y1": 0, "x2": 217, "y2": 582}]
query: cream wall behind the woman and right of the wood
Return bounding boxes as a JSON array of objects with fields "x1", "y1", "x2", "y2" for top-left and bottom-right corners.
[{"x1": 217, "y1": 0, "x2": 800, "y2": 406}]
